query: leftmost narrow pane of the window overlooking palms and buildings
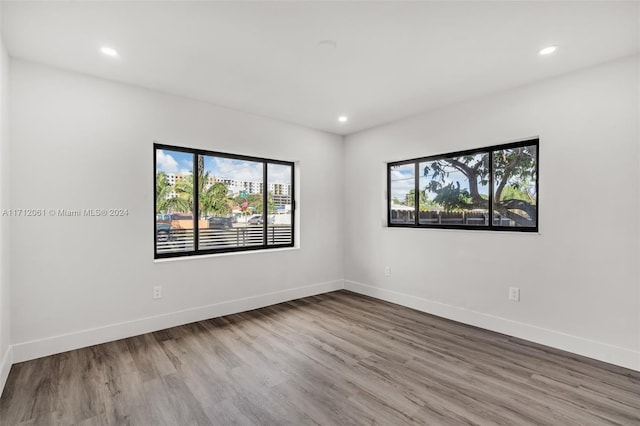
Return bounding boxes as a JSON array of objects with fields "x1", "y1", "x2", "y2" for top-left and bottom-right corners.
[{"x1": 156, "y1": 149, "x2": 194, "y2": 253}]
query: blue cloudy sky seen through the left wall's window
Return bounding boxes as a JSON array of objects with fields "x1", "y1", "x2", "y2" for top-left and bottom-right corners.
[{"x1": 156, "y1": 149, "x2": 291, "y2": 184}]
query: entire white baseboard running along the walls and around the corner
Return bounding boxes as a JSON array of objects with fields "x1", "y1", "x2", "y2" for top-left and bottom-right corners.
[{"x1": 7, "y1": 280, "x2": 640, "y2": 374}]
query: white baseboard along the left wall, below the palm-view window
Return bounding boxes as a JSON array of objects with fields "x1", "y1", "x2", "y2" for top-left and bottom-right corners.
[{"x1": 11, "y1": 280, "x2": 344, "y2": 364}]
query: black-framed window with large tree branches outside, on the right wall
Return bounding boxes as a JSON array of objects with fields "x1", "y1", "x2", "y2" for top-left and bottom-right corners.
[{"x1": 387, "y1": 139, "x2": 539, "y2": 232}]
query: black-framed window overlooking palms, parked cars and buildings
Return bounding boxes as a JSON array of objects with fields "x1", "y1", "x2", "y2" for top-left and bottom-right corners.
[{"x1": 153, "y1": 144, "x2": 295, "y2": 259}]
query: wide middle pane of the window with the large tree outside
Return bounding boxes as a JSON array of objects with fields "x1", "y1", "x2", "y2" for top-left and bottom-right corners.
[{"x1": 419, "y1": 153, "x2": 489, "y2": 226}]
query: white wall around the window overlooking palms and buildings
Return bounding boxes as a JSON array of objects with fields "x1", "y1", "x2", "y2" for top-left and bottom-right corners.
[{"x1": 10, "y1": 60, "x2": 343, "y2": 362}]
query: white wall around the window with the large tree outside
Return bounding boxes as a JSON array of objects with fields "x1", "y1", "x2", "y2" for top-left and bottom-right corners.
[{"x1": 345, "y1": 58, "x2": 640, "y2": 369}]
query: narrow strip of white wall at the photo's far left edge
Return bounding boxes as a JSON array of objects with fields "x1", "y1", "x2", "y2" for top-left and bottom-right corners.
[{"x1": 0, "y1": 34, "x2": 11, "y2": 389}]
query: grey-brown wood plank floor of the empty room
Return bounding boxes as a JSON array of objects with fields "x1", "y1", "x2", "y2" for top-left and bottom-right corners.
[{"x1": 0, "y1": 291, "x2": 640, "y2": 426}]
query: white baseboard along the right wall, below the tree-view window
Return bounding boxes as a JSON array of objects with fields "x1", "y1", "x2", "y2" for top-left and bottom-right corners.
[{"x1": 344, "y1": 280, "x2": 640, "y2": 371}]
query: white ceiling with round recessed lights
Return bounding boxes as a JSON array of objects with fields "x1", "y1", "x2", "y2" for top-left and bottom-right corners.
[{"x1": 2, "y1": 1, "x2": 639, "y2": 134}]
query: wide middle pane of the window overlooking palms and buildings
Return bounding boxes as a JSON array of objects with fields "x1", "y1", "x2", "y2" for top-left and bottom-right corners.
[{"x1": 198, "y1": 156, "x2": 264, "y2": 250}]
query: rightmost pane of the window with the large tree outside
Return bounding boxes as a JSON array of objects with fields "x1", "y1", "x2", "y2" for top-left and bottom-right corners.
[{"x1": 493, "y1": 145, "x2": 538, "y2": 228}]
